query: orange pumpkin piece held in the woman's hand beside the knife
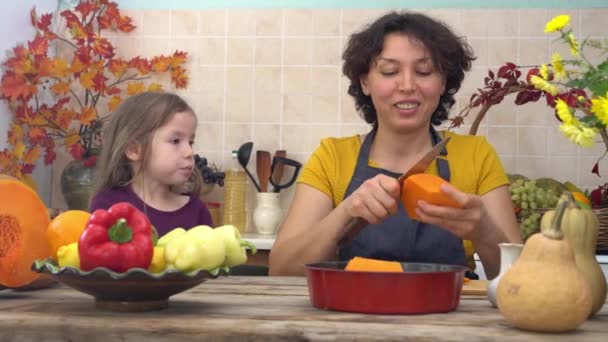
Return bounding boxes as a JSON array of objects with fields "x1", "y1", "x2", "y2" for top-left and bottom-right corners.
[{"x1": 401, "y1": 173, "x2": 462, "y2": 220}]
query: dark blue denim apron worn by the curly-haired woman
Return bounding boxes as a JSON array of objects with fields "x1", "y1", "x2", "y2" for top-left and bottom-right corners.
[{"x1": 338, "y1": 128, "x2": 467, "y2": 266}]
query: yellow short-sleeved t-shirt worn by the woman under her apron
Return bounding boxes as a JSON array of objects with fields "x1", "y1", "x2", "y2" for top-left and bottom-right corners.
[{"x1": 298, "y1": 132, "x2": 509, "y2": 269}]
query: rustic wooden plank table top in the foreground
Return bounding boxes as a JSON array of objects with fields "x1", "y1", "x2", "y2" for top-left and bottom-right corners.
[{"x1": 0, "y1": 277, "x2": 608, "y2": 342}]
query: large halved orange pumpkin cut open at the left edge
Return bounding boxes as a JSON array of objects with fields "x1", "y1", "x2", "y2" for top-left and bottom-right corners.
[{"x1": 0, "y1": 175, "x2": 51, "y2": 287}]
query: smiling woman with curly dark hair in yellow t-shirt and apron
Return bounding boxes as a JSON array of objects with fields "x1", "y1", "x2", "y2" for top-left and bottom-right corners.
[{"x1": 270, "y1": 13, "x2": 521, "y2": 278}]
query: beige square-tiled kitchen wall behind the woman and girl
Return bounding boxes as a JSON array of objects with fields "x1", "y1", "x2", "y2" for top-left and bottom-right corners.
[{"x1": 53, "y1": 9, "x2": 608, "y2": 223}]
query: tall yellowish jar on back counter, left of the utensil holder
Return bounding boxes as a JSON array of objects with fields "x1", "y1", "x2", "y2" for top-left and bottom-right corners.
[{"x1": 222, "y1": 170, "x2": 247, "y2": 233}]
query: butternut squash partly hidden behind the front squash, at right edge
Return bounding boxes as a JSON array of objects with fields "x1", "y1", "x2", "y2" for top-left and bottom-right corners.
[{"x1": 540, "y1": 193, "x2": 606, "y2": 316}]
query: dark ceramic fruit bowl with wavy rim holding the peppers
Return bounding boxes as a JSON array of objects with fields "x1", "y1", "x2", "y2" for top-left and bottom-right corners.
[{"x1": 32, "y1": 258, "x2": 228, "y2": 311}]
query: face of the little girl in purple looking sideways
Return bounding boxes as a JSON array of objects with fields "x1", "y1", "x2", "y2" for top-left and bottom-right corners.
[{"x1": 144, "y1": 112, "x2": 196, "y2": 185}]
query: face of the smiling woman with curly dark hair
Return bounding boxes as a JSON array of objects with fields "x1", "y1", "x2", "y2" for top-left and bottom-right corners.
[{"x1": 361, "y1": 33, "x2": 445, "y2": 132}]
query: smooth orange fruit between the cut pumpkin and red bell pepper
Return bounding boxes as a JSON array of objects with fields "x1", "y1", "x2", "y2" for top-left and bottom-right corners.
[{"x1": 46, "y1": 210, "x2": 91, "y2": 260}]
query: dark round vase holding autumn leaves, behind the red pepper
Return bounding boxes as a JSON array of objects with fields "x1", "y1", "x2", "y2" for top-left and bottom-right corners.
[{"x1": 61, "y1": 160, "x2": 97, "y2": 211}]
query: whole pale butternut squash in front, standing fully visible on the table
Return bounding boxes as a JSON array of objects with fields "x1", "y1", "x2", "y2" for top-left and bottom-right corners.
[{"x1": 496, "y1": 195, "x2": 592, "y2": 332}]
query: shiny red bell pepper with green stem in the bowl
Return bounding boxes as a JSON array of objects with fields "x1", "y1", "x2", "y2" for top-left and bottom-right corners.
[{"x1": 78, "y1": 202, "x2": 154, "y2": 272}]
